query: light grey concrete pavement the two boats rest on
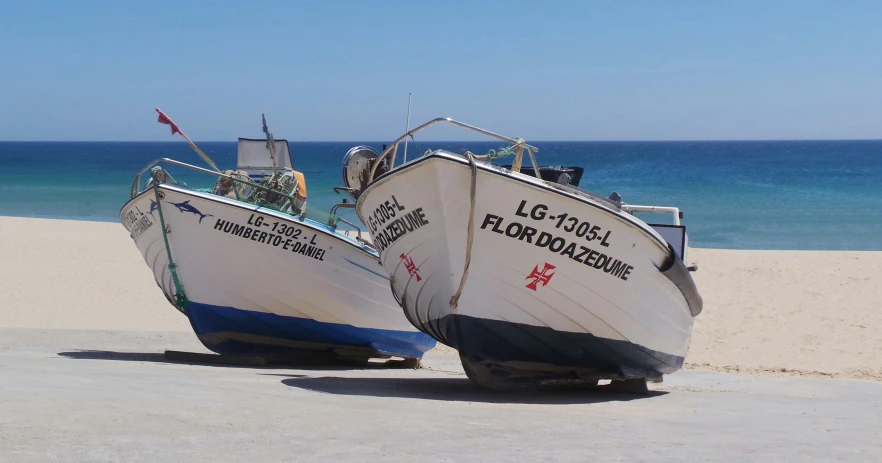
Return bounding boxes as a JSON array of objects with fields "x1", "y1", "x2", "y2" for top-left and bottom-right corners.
[{"x1": 0, "y1": 329, "x2": 882, "y2": 462}]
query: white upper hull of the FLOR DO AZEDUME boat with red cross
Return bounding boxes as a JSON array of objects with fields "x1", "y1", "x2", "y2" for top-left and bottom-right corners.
[{"x1": 357, "y1": 153, "x2": 693, "y2": 357}]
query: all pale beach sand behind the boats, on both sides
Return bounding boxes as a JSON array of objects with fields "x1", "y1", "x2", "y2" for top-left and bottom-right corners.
[{"x1": 0, "y1": 217, "x2": 882, "y2": 380}]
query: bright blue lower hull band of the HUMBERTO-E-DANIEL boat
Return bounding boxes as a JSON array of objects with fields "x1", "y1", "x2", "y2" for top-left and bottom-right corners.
[{"x1": 187, "y1": 301, "x2": 435, "y2": 358}]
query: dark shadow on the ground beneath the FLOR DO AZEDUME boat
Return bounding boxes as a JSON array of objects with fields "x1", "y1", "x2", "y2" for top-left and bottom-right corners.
[{"x1": 274, "y1": 375, "x2": 667, "y2": 405}]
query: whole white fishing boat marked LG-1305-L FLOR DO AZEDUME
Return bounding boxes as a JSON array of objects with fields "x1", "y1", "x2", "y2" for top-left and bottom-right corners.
[{"x1": 348, "y1": 118, "x2": 702, "y2": 389}]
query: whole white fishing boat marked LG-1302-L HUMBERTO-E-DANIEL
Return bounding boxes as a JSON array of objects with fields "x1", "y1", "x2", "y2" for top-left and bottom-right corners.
[{"x1": 120, "y1": 110, "x2": 435, "y2": 360}]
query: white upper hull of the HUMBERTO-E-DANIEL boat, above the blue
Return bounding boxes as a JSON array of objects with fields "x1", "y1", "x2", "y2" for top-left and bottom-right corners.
[{"x1": 120, "y1": 185, "x2": 417, "y2": 332}]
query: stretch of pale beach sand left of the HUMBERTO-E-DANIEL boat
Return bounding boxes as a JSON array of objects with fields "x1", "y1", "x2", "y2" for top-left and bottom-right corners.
[{"x1": 0, "y1": 217, "x2": 190, "y2": 331}]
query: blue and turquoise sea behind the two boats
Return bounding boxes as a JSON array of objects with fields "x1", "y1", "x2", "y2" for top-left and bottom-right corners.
[{"x1": 0, "y1": 141, "x2": 882, "y2": 250}]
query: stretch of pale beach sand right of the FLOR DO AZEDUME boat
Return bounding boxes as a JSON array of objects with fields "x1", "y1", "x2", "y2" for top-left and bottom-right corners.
[{"x1": 686, "y1": 249, "x2": 882, "y2": 380}]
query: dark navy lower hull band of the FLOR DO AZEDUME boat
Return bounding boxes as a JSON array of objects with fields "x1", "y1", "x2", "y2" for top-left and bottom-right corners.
[{"x1": 423, "y1": 315, "x2": 684, "y2": 378}]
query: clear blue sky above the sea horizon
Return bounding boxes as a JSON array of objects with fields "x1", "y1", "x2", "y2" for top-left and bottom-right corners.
[{"x1": 0, "y1": 0, "x2": 882, "y2": 141}]
